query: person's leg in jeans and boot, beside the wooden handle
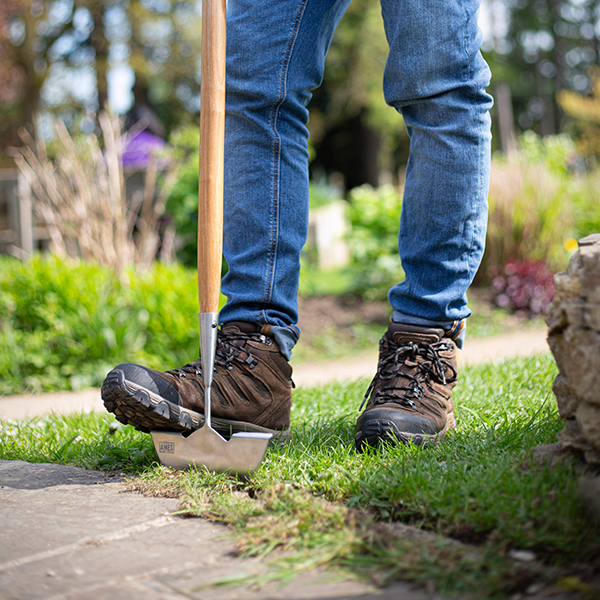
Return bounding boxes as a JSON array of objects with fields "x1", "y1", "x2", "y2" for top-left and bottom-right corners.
[{"x1": 102, "y1": 0, "x2": 349, "y2": 437}]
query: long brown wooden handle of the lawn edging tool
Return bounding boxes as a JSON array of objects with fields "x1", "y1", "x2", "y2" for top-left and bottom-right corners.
[{"x1": 198, "y1": 0, "x2": 226, "y2": 313}]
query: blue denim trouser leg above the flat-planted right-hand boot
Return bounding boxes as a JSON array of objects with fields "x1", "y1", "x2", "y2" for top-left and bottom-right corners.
[{"x1": 382, "y1": 0, "x2": 492, "y2": 342}]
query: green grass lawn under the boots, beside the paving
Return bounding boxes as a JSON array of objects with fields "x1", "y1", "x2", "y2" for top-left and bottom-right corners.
[{"x1": 0, "y1": 355, "x2": 600, "y2": 598}]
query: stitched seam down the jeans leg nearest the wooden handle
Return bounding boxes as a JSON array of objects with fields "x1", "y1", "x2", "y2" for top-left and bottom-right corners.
[{"x1": 261, "y1": 0, "x2": 308, "y2": 322}]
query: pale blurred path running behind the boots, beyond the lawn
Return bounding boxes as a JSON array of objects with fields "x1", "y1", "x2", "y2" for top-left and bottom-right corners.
[{"x1": 0, "y1": 329, "x2": 548, "y2": 420}]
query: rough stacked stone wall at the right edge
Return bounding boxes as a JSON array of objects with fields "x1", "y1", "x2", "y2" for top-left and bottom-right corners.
[{"x1": 546, "y1": 233, "x2": 600, "y2": 467}]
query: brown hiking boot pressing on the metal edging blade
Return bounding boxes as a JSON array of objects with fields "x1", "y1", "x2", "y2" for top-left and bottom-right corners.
[{"x1": 102, "y1": 321, "x2": 293, "y2": 440}]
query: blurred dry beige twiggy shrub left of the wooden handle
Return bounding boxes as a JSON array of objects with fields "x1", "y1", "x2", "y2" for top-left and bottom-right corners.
[{"x1": 15, "y1": 111, "x2": 175, "y2": 272}]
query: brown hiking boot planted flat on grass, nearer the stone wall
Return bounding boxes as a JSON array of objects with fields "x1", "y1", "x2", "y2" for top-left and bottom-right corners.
[{"x1": 355, "y1": 323, "x2": 457, "y2": 450}]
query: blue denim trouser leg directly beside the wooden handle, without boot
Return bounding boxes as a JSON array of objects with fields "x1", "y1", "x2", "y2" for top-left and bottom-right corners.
[{"x1": 220, "y1": 0, "x2": 350, "y2": 358}]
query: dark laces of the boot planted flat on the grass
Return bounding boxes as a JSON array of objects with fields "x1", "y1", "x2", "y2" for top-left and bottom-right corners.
[{"x1": 359, "y1": 336, "x2": 457, "y2": 410}]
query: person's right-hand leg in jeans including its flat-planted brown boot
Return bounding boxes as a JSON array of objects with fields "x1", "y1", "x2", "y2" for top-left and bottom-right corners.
[{"x1": 356, "y1": 0, "x2": 492, "y2": 449}]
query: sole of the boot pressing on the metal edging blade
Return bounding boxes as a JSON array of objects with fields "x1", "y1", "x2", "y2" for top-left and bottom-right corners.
[{"x1": 101, "y1": 369, "x2": 290, "y2": 442}]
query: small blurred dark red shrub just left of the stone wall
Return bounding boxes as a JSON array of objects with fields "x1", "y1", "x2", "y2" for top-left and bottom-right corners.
[{"x1": 490, "y1": 261, "x2": 554, "y2": 317}]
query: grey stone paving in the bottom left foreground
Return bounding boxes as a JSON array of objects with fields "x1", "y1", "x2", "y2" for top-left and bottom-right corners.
[{"x1": 0, "y1": 461, "x2": 442, "y2": 600}]
